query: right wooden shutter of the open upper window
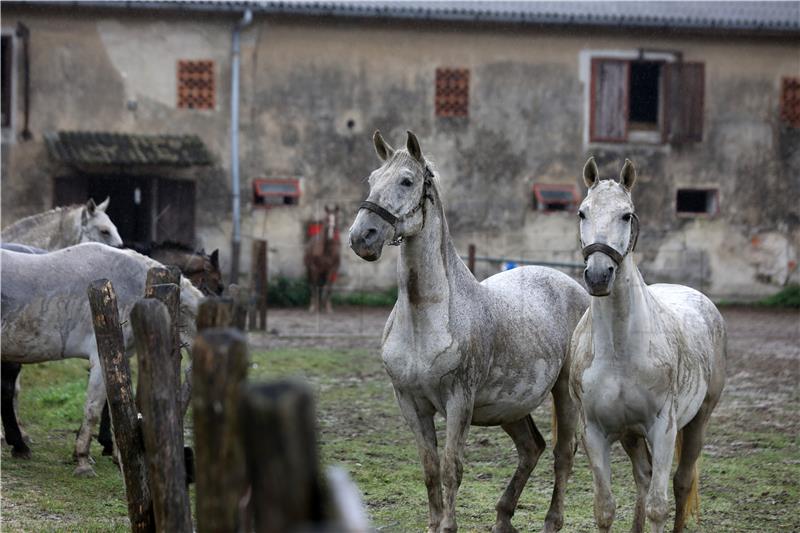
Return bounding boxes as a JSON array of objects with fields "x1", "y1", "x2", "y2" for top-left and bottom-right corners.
[{"x1": 664, "y1": 62, "x2": 705, "y2": 144}]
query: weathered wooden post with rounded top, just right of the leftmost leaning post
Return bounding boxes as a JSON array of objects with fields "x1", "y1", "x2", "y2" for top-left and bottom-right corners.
[{"x1": 131, "y1": 298, "x2": 192, "y2": 533}]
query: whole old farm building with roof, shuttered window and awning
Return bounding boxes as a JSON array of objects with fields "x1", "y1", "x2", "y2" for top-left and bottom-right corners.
[{"x1": 2, "y1": 1, "x2": 800, "y2": 298}]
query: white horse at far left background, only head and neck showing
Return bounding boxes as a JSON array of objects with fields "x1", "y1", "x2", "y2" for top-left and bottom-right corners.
[{"x1": 2, "y1": 198, "x2": 122, "y2": 250}]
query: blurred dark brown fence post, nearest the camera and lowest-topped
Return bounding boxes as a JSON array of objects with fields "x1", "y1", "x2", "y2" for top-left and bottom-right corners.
[{"x1": 240, "y1": 381, "x2": 325, "y2": 533}]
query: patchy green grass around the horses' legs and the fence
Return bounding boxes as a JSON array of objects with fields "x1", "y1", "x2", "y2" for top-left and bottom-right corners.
[{"x1": 2, "y1": 348, "x2": 800, "y2": 533}]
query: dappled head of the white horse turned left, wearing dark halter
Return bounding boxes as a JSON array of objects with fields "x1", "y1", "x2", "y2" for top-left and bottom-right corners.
[{"x1": 350, "y1": 131, "x2": 433, "y2": 261}]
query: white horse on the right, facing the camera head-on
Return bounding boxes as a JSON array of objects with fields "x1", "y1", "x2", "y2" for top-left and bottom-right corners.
[{"x1": 570, "y1": 158, "x2": 726, "y2": 532}]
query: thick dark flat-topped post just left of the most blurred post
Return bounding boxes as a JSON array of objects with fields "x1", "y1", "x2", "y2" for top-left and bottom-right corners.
[{"x1": 192, "y1": 328, "x2": 248, "y2": 533}]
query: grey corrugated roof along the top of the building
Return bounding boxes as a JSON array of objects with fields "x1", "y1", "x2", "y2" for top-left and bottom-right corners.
[{"x1": 9, "y1": 0, "x2": 800, "y2": 32}]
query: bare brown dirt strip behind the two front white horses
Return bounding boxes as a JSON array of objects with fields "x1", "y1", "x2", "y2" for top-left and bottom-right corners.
[{"x1": 250, "y1": 307, "x2": 800, "y2": 454}]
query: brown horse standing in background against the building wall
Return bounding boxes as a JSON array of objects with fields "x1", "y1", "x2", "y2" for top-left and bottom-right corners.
[{"x1": 303, "y1": 205, "x2": 342, "y2": 313}]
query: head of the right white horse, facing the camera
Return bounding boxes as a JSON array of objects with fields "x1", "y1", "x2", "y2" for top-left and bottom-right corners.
[{"x1": 578, "y1": 157, "x2": 639, "y2": 296}]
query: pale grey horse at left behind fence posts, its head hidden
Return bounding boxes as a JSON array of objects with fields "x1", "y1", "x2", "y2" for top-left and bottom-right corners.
[{"x1": 0, "y1": 243, "x2": 203, "y2": 475}]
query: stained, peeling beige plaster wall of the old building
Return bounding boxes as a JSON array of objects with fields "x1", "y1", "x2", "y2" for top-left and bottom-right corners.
[{"x1": 3, "y1": 8, "x2": 800, "y2": 297}]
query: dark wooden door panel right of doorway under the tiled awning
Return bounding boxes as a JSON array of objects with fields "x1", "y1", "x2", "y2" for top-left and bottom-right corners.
[{"x1": 156, "y1": 178, "x2": 195, "y2": 246}]
